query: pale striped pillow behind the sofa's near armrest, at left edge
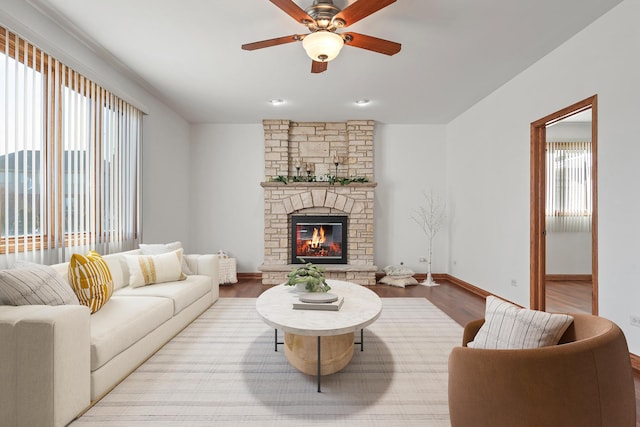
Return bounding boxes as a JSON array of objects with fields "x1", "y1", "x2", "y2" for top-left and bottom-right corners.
[{"x1": 0, "y1": 262, "x2": 80, "y2": 305}]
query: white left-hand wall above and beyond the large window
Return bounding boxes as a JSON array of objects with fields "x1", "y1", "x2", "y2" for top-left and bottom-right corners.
[{"x1": 0, "y1": 0, "x2": 190, "y2": 251}]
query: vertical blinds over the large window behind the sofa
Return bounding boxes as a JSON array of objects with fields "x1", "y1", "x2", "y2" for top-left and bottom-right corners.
[{"x1": 0, "y1": 27, "x2": 142, "y2": 264}]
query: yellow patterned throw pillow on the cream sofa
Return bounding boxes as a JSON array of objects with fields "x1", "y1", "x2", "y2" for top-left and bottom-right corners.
[{"x1": 69, "y1": 251, "x2": 113, "y2": 314}]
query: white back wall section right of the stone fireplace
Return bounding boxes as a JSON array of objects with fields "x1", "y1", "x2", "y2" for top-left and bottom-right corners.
[{"x1": 374, "y1": 124, "x2": 448, "y2": 273}]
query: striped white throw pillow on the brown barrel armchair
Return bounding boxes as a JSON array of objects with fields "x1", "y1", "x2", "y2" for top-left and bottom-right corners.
[{"x1": 467, "y1": 295, "x2": 573, "y2": 349}]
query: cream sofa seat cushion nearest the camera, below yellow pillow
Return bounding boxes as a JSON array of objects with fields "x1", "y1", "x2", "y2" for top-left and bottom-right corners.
[{"x1": 91, "y1": 295, "x2": 173, "y2": 371}]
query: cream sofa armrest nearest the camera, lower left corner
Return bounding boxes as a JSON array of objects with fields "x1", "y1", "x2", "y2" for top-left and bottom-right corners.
[{"x1": 0, "y1": 305, "x2": 91, "y2": 426}]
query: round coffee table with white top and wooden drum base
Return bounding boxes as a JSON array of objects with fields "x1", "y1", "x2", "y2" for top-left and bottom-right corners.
[{"x1": 256, "y1": 280, "x2": 382, "y2": 391}]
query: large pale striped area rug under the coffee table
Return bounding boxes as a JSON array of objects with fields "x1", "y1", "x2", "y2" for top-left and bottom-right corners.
[{"x1": 72, "y1": 298, "x2": 462, "y2": 427}]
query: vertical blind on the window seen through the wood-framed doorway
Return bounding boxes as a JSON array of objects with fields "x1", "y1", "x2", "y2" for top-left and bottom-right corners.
[{"x1": 546, "y1": 142, "x2": 592, "y2": 232}]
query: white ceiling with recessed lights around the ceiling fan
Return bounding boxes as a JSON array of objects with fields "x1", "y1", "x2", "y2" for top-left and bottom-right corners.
[{"x1": 30, "y1": 0, "x2": 621, "y2": 124}]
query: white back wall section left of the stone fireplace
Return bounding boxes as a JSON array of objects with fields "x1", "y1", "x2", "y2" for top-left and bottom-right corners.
[{"x1": 189, "y1": 123, "x2": 264, "y2": 272}]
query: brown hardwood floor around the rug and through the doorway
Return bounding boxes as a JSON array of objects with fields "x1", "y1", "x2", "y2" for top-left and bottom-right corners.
[{"x1": 220, "y1": 279, "x2": 640, "y2": 427}]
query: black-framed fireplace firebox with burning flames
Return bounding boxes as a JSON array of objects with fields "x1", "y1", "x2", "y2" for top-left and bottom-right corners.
[{"x1": 291, "y1": 215, "x2": 348, "y2": 264}]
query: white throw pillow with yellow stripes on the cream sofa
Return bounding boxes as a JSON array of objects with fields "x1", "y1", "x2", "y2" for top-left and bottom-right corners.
[{"x1": 124, "y1": 249, "x2": 187, "y2": 288}]
